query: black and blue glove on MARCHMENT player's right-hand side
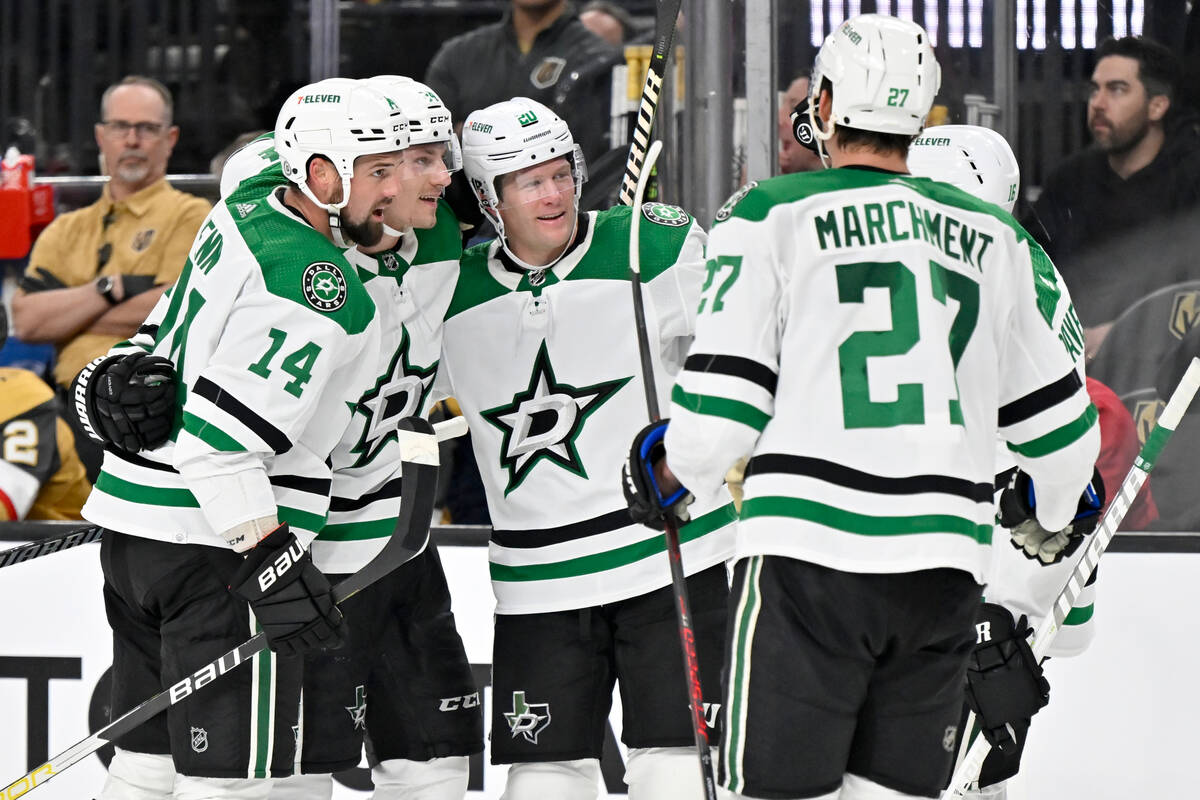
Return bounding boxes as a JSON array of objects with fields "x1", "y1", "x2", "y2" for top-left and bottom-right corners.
[{"x1": 997, "y1": 469, "x2": 1105, "y2": 566}]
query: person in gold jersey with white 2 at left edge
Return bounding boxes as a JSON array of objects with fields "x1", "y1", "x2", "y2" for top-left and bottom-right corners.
[{"x1": 0, "y1": 303, "x2": 91, "y2": 522}]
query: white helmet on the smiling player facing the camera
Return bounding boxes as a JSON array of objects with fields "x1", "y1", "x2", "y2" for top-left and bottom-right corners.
[{"x1": 462, "y1": 97, "x2": 588, "y2": 220}]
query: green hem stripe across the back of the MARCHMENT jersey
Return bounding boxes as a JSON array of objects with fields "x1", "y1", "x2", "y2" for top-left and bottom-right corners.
[{"x1": 742, "y1": 497, "x2": 991, "y2": 545}]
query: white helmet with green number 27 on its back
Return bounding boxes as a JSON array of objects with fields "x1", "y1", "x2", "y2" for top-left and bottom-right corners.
[{"x1": 809, "y1": 14, "x2": 942, "y2": 140}]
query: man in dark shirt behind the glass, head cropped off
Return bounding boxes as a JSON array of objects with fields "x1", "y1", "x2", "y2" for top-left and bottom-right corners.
[{"x1": 425, "y1": 0, "x2": 623, "y2": 162}]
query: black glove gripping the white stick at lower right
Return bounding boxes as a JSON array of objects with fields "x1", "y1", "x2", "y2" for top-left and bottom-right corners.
[{"x1": 966, "y1": 603, "x2": 1050, "y2": 784}]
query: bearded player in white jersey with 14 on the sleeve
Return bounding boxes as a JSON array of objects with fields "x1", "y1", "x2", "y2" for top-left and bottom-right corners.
[{"x1": 76, "y1": 79, "x2": 408, "y2": 800}]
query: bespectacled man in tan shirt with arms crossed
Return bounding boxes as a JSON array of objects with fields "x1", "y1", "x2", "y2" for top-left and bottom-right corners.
[{"x1": 12, "y1": 76, "x2": 209, "y2": 481}]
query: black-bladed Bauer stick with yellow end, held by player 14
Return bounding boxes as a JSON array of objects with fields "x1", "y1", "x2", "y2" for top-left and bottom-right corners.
[{"x1": 0, "y1": 417, "x2": 466, "y2": 798}]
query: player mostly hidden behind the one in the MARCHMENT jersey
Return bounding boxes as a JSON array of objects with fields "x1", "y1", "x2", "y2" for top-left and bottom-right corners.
[{"x1": 908, "y1": 125, "x2": 1123, "y2": 800}]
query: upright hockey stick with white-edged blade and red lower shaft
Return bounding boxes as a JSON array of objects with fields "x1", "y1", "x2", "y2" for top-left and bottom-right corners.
[{"x1": 626, "y1": 139, "x2": 716, "y2": 800}]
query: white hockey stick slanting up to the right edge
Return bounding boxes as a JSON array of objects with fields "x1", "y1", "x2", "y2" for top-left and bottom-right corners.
[{"x1": 942, "y1": 359, "x2": 1200, "y2": 800}]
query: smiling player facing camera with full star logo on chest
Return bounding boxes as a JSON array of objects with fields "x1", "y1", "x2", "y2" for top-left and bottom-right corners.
[{"x1": 438, "y1": 97, "x2": 732, "y2": 800}]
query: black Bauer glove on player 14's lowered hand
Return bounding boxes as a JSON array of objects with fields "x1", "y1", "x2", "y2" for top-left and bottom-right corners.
[{"x1": 229, "y1": 523, "x2": 346, "y2": 656}]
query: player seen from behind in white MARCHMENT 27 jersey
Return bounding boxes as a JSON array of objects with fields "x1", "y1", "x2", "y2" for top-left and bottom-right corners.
[{"x1": 624, "y1": 14, "x2": 1099, "y2": 799}]
